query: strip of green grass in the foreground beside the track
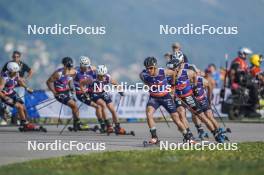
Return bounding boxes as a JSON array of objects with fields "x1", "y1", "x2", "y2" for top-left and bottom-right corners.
[{"x1": 0, "y1": 142, "x2": 264, "y2": 175}]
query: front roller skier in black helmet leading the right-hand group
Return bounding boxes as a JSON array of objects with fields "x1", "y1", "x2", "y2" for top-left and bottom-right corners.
[{"x1": 140, "y1": 57, "x2": 192, "y2": 144}]
